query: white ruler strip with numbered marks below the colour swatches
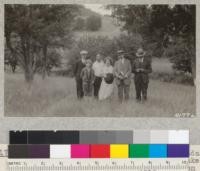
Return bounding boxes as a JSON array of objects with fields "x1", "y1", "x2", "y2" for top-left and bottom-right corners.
[{"x1": 8, "y1": 159, "x2": 189, "y2": 171}]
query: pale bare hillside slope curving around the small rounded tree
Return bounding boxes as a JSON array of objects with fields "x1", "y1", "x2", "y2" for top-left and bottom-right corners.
[{"x1": 75, "y1": 7, "x2": 121, "y2": 39}]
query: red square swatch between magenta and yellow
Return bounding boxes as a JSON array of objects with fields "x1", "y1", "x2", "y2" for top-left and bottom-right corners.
[{"x1": 90, "y1": 144, "x2": 110, "y2": 158}]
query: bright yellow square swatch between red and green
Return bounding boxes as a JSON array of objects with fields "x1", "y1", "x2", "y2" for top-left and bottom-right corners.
[{"x1": 110, "y1": 144, "x2": 129, "y2": 158}]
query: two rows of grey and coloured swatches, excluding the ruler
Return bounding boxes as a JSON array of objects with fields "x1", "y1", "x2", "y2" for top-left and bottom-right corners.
[{"x1": 8, "y1": 130, "x2": 189, "y2": 158}]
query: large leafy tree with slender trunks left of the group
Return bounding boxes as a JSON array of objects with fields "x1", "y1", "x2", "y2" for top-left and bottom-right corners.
[{"x1": 5, "y1": 4, "x2": 78, "y2": 83}]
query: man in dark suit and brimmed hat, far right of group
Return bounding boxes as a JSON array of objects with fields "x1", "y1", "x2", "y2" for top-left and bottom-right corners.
[{"x1": 132, "y1": 48, "x2": 152, "y2": 101}]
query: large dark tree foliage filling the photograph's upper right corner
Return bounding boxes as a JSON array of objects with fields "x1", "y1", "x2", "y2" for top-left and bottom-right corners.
[{"x1": 107, "y1": 5, "x2": 196, "y2": 83}]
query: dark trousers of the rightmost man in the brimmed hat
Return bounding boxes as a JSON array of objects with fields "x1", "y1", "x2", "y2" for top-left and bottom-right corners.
[{"x1": 135, "y1": 76, "x2": 148, "y2": 100}]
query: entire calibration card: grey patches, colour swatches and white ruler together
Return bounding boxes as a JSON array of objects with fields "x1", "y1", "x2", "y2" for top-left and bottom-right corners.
[{"x1": 1, "y1": 130, "x2": 200, "y2": 171}]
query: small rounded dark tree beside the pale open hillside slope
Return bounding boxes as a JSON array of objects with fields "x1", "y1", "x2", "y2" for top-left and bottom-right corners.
[{"x1": 86, "y1": 15, "x2": 101, "y2": 31}]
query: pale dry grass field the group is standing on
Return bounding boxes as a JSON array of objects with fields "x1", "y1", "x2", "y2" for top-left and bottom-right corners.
[{"x1": 5, "y1": 73, "x2": 195, "y2": 117}]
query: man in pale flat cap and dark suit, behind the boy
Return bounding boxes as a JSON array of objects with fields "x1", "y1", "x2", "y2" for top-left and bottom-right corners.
[{"x1": 74, "y1": 50, "x2": 88, "y2": 99}]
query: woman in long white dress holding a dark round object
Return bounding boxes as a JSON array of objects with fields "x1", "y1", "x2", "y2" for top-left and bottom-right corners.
[{"x1": 99, "y1": 57, "x2": 114, "y2": 100}]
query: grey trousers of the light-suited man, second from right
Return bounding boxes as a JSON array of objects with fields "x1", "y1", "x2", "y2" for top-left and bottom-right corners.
[{"x1": 118, "y1": 81, "x2": 130, "y2": 102}]
